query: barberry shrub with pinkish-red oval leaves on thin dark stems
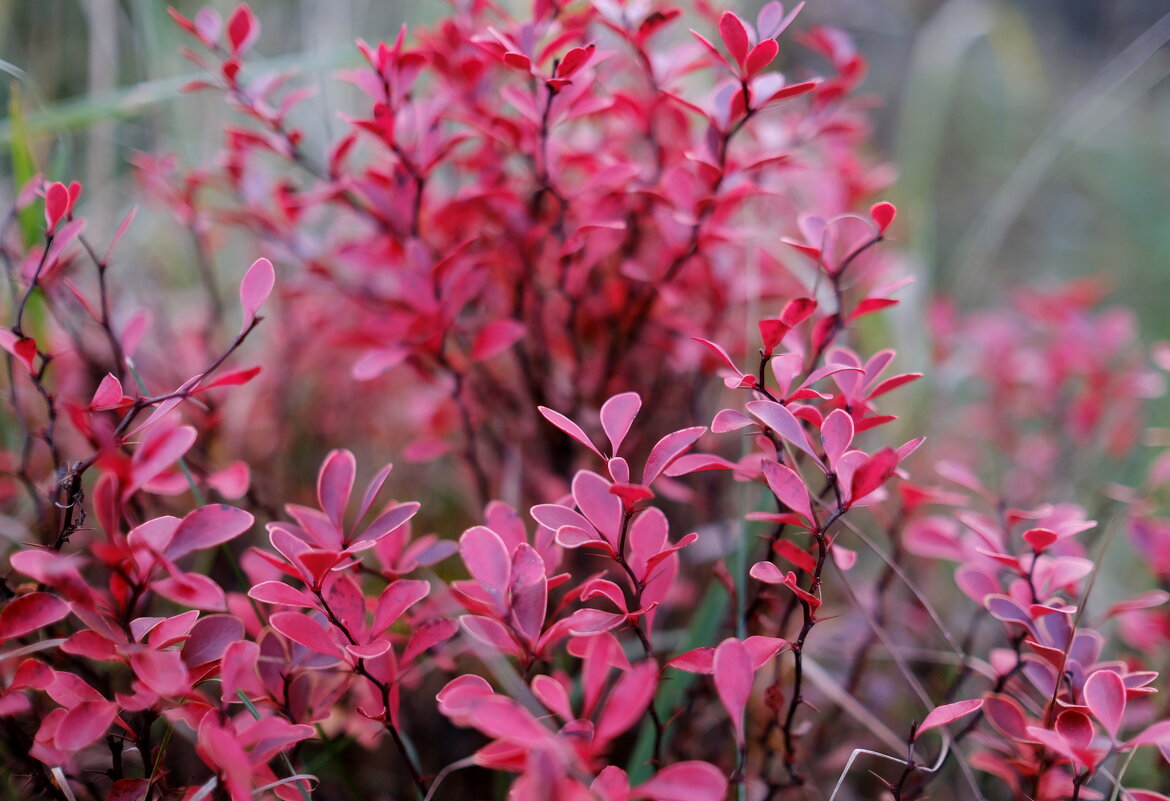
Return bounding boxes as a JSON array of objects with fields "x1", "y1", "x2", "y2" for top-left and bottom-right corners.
[{"x1": 0, "y1": 0, "x2": 1170, "y2": 801}]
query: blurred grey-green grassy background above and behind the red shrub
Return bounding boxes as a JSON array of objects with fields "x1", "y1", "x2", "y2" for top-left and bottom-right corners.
[{"x1": 0, "y1": 0, "x2": 1170, "y2": 360}]
